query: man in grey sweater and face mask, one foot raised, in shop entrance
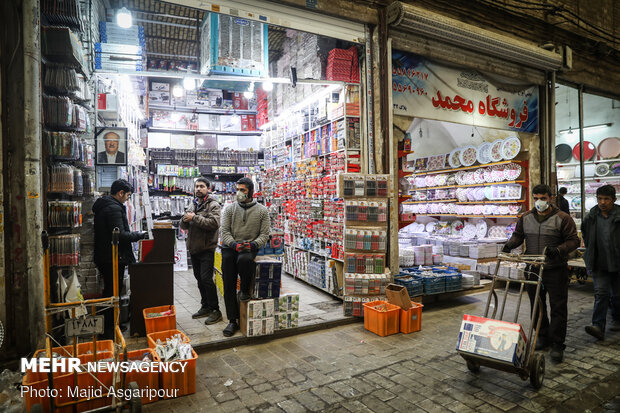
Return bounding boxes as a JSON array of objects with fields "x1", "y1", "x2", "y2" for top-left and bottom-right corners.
[{"x1": 222, "y1": 178, "x2": 271, "y2": 337}]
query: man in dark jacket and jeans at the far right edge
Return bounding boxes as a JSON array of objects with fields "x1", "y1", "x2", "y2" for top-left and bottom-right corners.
[{"x1": 581, "y1": 185, "x2": 620, "y2": 340}]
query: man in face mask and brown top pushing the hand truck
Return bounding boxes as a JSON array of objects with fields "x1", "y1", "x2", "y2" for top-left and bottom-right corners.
[{"x1": 503, "y1": 185, "x2": 579, "y2": 363}]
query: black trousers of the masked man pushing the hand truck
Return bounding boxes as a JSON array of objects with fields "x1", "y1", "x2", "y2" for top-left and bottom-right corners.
[{"x1": 527, "y1": 267, "x2": 568, "y2": 349}]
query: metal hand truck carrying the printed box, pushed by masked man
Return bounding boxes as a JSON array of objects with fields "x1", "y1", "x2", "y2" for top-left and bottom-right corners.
[{"x1": 459, "y1": 251, "x2": 545, "y2": 389}]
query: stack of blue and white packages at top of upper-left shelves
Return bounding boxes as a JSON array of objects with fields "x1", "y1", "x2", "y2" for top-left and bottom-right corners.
[{"x1": 95, "y1": 22, "x2": 147, "y2": 72}]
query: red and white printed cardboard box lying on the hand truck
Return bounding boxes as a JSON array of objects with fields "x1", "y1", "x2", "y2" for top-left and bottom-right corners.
[{"x1": 456, "y1": 314, "x2": 527, "y2": 367}]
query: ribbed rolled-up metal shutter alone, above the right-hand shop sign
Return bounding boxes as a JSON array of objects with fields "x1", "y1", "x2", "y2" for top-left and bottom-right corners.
[{"x1": 387, "y1": 1, "x2": 563, "y2": 70}]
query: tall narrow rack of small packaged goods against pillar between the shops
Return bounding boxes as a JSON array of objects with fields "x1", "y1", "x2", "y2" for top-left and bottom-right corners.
[{"x1": 338, "y1": 174, "x2": 391, "y2": 317}]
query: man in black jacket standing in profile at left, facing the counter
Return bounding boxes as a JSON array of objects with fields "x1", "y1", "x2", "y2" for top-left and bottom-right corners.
[{"x1": 93, "y1": 179, "x2": 148, "y2": 338}]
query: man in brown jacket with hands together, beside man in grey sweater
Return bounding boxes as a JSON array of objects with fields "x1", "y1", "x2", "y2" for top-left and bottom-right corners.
[{"x1": 180, "y1": 178, "x2": 222, "y2": 324}]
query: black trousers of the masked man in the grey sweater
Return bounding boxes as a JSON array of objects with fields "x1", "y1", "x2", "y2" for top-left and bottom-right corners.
[{"x1": 222, "y1": 248, "x2": 256, "y2": 321}]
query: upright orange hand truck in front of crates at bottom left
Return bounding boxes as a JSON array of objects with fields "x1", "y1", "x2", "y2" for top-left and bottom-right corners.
[{"x1": 30, "y1": 228, "x2": 142, "y2": 413}]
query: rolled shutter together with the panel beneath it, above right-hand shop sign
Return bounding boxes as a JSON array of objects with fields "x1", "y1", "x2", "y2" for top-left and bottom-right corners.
[{"x1": 387, "y1": 1, "x2": 563, "y2": 84}]
